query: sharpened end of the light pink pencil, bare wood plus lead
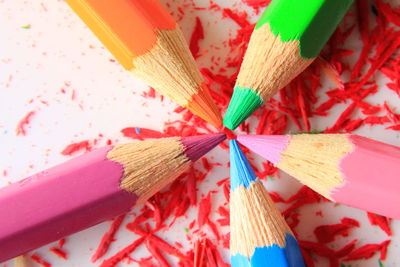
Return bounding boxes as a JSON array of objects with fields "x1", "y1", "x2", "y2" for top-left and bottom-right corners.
[{"x1": 238, "y1": 134, "x2": 353, "y2": 199}]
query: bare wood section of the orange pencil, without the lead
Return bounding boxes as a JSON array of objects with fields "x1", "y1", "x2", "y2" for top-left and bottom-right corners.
[{"x1": 131, "y1": 26, "x2": 204, "y2": 106}]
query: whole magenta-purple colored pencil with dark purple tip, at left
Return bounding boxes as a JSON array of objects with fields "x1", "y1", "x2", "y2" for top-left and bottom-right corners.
[{"x1": 0, "y1": 134, "x2": 225, "y2": 262}]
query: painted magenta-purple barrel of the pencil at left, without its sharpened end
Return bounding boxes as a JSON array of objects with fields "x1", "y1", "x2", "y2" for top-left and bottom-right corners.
[{"x1": 0, "y1": 147, "x2": 137, "y2": 262}]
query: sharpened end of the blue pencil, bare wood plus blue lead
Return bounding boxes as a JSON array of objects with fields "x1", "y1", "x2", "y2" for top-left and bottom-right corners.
[{"x1": 230, "y1": 140, "x2": 291, "y2": 257}]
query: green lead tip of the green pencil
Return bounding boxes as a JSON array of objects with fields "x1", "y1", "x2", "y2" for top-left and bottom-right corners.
[{"x1": 223, "y1": 86, "x2": 264, "y2": 130}]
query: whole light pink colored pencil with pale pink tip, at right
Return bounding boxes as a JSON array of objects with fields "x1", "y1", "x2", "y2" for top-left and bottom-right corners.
[{"x1": 238, "y1": 134, "x2": 400, "y2": 219}]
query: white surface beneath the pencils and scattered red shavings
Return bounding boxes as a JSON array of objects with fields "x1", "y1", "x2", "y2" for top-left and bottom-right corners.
[{"x1": 0, "y1": 0, "x2": 400, "y2": 267}]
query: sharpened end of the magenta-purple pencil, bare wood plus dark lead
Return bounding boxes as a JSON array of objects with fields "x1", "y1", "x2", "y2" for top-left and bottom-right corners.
[{"x1": 107, "y1": 133, "x2": 226, "y2": 205}]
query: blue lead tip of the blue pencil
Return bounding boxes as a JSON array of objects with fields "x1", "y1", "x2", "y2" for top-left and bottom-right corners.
[{"x1": 229, "y1": 140, "x2": 257, "y2": 192}]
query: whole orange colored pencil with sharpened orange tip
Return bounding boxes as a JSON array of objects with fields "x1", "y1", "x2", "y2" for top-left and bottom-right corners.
[{"x1": 66, "y1": 0, "x2": 222, "y2": 128}]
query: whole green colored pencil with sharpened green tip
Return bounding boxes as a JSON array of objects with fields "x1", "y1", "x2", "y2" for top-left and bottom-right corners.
[{"x1": 224, "y1": 0, "x2": 353, "y2": 130}]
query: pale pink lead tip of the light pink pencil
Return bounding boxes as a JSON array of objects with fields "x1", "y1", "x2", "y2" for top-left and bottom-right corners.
[{"x1": 237, "y1": 135, "x2": 290, "y2": 164}]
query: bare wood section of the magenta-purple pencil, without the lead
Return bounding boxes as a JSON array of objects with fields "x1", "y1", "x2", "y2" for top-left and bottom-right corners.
[{"x1": 107, "y1": 138, "x2": 191, "y2": 205}]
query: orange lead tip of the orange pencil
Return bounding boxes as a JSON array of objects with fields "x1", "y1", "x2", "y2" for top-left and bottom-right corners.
[{"x1": 187, "y1": 84, "x2": 222, "y2": 129}]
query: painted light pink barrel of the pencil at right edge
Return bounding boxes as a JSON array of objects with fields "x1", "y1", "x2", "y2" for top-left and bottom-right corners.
[{"x1": 331, "y1": 135, "x2": 400, "y2": 219}]
